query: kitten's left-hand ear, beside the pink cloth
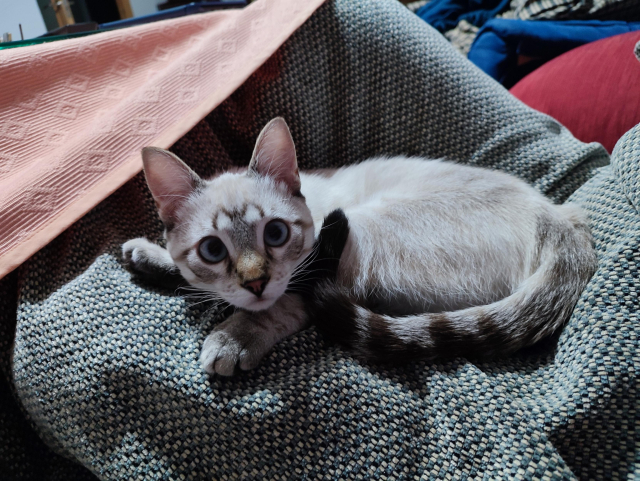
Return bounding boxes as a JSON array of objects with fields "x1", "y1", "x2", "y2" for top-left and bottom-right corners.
[{"x1": 142, "y1": 147, "x2": 203, "y2": 226}]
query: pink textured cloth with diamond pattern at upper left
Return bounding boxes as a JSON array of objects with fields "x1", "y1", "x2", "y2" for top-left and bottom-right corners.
[{"x1": 0, "y1": 0, "x2": 323, "y2": 277}]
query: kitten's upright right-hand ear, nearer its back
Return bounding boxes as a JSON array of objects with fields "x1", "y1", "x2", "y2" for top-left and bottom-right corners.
[{"x1": 249, "y1": 117, "x2": 300, "y2": 195}]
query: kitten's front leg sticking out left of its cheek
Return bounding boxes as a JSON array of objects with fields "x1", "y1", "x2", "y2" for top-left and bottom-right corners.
[{"x1": 122, "y1": 237, "x2": 184, "y2": 287}]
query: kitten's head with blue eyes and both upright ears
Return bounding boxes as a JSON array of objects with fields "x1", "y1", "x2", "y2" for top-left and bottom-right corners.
[{"x1": 142, "y1": 118, "x2": 314, "y2": 310}]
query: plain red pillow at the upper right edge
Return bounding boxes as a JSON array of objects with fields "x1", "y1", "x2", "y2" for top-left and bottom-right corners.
[{"x1": 511, "y1": 31, "x2": 640, "y2": 152}]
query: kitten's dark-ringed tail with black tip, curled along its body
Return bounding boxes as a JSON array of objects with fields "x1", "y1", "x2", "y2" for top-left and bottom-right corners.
[{"x1": 309, "y1": 206, "x2": 596, "y2": 362}]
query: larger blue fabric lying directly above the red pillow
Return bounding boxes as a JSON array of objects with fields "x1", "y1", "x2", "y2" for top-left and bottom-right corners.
[{"x1": 468, "y1": 18, "x2": 640, "y2": 88}]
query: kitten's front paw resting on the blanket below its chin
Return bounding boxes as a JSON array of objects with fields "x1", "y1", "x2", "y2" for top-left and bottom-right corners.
[{"x1": 200, "y1": 311, "x2": 272, "y2": 376}]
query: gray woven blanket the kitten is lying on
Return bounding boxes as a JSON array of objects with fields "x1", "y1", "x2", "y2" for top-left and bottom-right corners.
[{"x1": 0, "y1": 0, "x2": 640, "y2": 480}]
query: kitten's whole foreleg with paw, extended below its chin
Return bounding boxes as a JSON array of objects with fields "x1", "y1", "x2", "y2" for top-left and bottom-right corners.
[{"x1": 200, "y1": 294, "x2": 307, "y2": 376}]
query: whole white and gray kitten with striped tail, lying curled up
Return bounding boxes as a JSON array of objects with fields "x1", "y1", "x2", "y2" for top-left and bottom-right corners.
[{"x1": 123, "y1": 118, "x2": 596, "y2": 375}]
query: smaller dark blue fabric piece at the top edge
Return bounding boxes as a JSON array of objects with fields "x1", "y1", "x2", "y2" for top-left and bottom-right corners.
[{"x1": 416, "y1": 0, "x2": 510, "y2": 33}]
